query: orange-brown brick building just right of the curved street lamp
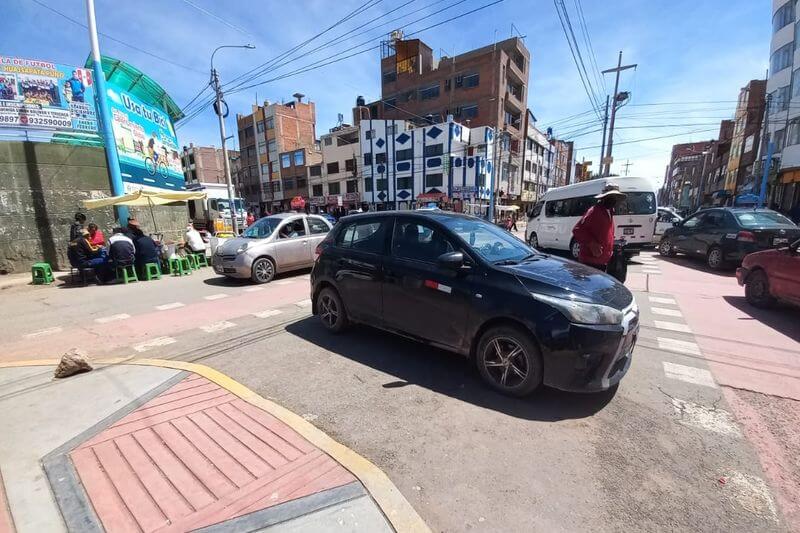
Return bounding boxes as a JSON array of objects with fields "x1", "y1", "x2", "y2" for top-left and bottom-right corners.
[{"x1": 236, "y1": 93, "x2": 316, "y2": 213}]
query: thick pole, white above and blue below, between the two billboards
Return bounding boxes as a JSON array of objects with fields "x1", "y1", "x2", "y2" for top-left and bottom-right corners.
[{"x1": 86, "y1": 0, "x2": 128, "y2": 222}]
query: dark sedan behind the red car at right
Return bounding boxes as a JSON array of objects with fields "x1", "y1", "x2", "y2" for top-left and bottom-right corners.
[{"x1": 658, "y1": 207, "x2": 800, "y2": 270}]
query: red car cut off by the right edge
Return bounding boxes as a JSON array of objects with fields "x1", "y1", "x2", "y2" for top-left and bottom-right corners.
[{"x1": 736, "y1": 240, "x2": 800, "y2": 307}]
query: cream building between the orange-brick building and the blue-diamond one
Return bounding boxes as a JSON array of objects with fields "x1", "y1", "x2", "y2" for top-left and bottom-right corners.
[{"x1": 311, "y1": 124, "x2": 364, "y2": 210}]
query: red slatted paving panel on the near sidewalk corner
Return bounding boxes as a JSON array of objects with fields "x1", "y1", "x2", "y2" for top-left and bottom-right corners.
[{"x1": 70, "y1": 376, "x2": 355, "y2": 532}]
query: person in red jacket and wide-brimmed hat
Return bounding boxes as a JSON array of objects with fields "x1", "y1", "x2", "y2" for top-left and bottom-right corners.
[{"x1": 572, "y1": 183, "x2": 625, "y2": 272}]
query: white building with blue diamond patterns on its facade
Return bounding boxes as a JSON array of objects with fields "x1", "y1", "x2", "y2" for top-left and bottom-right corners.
[{"x1": 359, "y1": 118, "x2": 495, "y2": 214}]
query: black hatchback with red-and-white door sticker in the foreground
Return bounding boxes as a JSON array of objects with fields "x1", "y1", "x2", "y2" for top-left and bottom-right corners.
[{"x1": 311, "y1": 211, "x2": 639, "y2": 396}]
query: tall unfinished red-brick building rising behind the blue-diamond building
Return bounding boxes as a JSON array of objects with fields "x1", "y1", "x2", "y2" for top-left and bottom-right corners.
[{"x1": 365, "y1": 32, "x2": 530, "y2": 208}]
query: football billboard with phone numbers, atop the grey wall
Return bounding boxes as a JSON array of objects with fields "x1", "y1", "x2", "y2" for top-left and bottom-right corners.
[{"x1": 0, "y1": 55, "x2": 97, "y2": 133}]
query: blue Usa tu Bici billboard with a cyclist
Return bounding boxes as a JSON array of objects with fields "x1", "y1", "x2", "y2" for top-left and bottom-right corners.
[{"x1": 106, "y1": 81, "x2": 184, "y2": 192}]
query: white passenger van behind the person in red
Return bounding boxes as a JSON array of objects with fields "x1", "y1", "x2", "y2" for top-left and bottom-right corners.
[{"x1": 525, "y1": 177, "x2": 658, "y2": 258}]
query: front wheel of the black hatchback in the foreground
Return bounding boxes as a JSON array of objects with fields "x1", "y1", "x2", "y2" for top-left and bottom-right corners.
[{"x1": 475, "y1": 326, "x2": 542, "y2": 396}]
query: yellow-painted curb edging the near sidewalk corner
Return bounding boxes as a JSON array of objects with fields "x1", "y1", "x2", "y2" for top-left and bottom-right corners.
[{"x1": 0, "y1": 357, "x2": 431, "y2": 533}]
